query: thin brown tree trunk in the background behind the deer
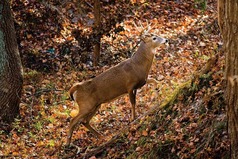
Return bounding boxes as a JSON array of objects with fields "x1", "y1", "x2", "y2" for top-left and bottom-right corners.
[{"x1": 93, "y1": 0, "x2": 101, "y2": 66}]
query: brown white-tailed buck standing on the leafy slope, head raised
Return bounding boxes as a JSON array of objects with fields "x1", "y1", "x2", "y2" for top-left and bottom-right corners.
[{"x1": 66, "y1": 35, "x2": 167, "y2": 145}]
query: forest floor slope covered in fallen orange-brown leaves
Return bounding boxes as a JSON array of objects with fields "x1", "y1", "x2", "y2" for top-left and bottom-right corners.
[{"x1": 0, "y1": 0, "x2": 229, "y2": 159}]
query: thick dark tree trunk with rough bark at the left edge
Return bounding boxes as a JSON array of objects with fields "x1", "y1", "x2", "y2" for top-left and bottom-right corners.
[{"x1": 0, "y1": 0, "x2": 23, "y2": 124}]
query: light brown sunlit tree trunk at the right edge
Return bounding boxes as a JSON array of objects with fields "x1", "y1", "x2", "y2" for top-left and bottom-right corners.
[{"x1": 218, "y1": 0, "x2": 238, "y2": 159}]
